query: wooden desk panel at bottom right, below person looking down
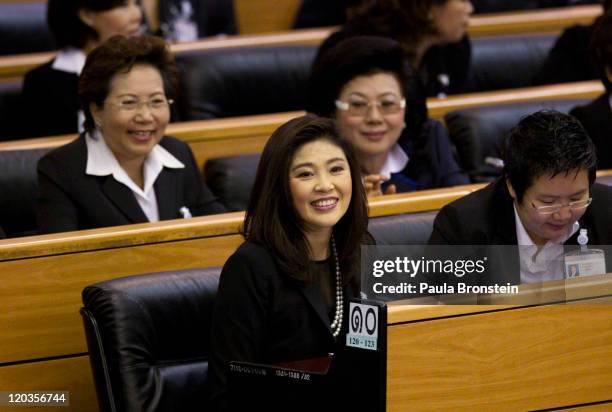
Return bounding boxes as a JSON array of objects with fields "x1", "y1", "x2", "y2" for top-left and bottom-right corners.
[{"x1": 387, "y1": 274, "x2": 612, "y2": 411}]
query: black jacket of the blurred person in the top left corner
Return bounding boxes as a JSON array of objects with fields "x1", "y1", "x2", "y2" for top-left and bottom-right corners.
[{"x1": 21, "y1": 61, "x2": 80, "y2": 137}]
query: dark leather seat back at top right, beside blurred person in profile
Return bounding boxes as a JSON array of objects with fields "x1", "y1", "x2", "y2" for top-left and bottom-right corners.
[{"x1": 465, "y1": 34, "x2": 557, "y2": 92}]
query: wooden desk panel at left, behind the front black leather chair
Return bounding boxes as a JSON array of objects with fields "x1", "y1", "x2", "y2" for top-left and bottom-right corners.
[{"x1": 0, "y1": 234, "x2": 242, "y2": 364}]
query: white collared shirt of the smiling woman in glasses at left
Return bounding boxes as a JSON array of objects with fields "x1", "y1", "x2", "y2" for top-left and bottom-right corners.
[{"x1": 85, "y1": 132, "x2": 185, "y2": 222}]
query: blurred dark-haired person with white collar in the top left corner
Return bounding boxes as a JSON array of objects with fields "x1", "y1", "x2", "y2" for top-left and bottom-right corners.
[{"x1": 22, "y1": 0, "x2": 142, "y2": 137}]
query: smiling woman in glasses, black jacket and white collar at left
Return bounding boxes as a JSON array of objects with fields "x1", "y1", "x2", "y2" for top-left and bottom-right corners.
[{"x1": 38, "y1": 36, "x2": 225, "y2": 232}]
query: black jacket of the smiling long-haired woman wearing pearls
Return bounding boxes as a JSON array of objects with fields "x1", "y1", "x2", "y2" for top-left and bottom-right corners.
[{"x1": 209, "y1": 242, "x2": 358, "y2": 410}]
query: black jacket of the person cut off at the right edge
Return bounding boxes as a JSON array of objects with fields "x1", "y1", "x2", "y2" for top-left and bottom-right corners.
[{"x1": 570, "y1": 93, "x2": 612, "y2": 169}]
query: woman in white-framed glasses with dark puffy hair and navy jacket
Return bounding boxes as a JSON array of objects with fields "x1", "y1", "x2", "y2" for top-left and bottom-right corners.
[{"x1": 308, "y1": 36, "x2": 469, "y2": 196}]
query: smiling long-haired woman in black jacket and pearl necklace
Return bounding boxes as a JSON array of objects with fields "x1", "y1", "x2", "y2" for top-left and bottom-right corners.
[{"x1": 209, "y1": 116, "x2": 368, "y2": 410}]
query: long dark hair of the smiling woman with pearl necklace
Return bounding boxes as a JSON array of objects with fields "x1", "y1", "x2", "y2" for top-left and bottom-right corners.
[{"x1": 244, "y1": 115, "x2": 369, "y2": 284}]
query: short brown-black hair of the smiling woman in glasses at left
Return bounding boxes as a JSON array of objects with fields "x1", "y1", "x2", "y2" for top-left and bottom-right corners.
[{"x1": 79, "y1": 36, "x2": 178, "y2": 132}]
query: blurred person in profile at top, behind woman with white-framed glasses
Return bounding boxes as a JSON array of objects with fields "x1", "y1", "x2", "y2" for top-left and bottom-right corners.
[{"x1": 318, "y1": 0, "x2": 473, "y2": 97}]
